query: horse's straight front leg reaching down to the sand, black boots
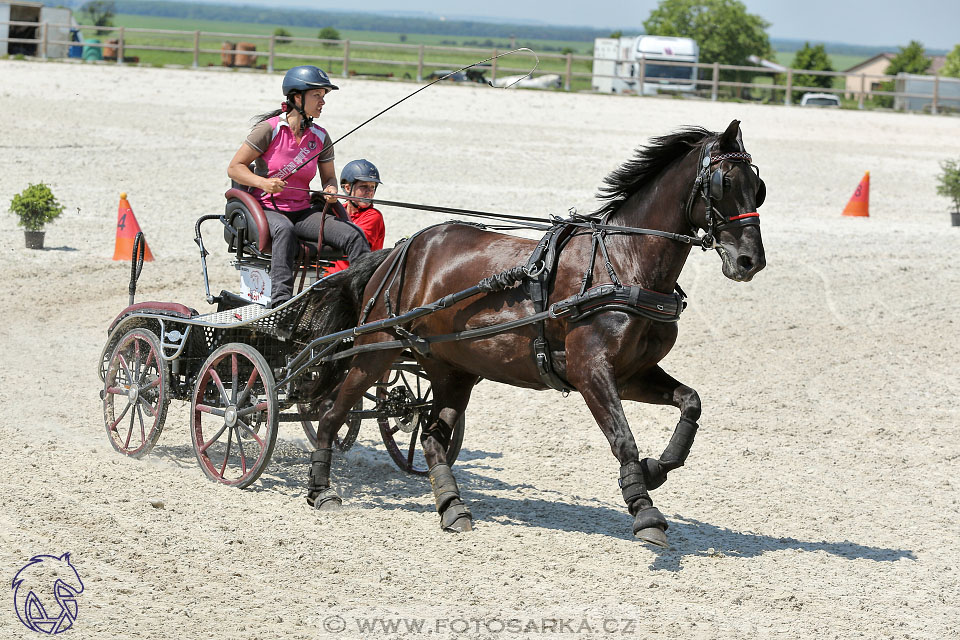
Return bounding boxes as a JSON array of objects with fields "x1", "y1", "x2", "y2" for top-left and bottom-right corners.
[{"x1": 567, "y1": 356, "x2": 668, "y2": 547}]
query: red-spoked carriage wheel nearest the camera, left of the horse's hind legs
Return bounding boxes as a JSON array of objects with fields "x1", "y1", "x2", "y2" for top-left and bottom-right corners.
[{"x1": 190, "y1": 342, "x2": 278, "y2": 489}]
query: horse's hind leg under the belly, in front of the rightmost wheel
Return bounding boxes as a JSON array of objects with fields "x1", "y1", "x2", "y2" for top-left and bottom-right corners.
[{"x1": 420, "y1": 361, "x2": 479, "y2": 533}]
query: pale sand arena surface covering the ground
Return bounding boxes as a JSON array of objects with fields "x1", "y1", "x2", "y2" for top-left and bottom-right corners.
[{"x1": 0, "y1": 61, "x2": 960, "y2": 639}]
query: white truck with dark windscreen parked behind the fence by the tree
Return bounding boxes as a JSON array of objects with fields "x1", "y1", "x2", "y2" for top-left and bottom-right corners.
[{"x1": 593, "y1": 36, "x2": 700, "y2": 96}]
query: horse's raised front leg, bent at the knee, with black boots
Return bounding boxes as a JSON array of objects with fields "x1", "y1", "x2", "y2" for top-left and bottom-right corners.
[{"x1": 620, "y1": 367, "x2": 700, "y2": 491}]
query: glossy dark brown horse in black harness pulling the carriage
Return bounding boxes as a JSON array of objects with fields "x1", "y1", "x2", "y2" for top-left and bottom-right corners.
[{"x1": 308, "y1": 120, "x2": 766, "y2": 545}]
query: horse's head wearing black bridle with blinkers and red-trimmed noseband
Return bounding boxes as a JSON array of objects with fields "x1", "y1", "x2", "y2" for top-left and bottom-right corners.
[{"x1": 687, "y1": 120, "x2": 767, "y2": 282}]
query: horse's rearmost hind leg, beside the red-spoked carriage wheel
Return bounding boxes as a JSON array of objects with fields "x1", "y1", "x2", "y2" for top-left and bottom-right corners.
[{"x1": 307, "y1": 349, "x2": 401, "y2": 510}]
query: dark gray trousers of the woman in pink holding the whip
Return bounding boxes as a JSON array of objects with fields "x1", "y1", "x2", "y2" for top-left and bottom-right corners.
[{"x1": 263, "y1": 205, "x2": 370, "y2": 307}]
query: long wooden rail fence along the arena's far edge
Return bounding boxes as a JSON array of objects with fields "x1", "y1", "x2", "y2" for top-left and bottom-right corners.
[{"x1": 0, "y1": 22, "x2": 960, "y2": 113}]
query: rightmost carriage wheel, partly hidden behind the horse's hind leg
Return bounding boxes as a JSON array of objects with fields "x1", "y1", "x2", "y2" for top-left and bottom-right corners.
[{"x1": 377, "y1": 369, "x2": 464, "y2": 476}]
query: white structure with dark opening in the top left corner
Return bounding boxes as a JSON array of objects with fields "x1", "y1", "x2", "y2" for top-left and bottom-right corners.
[{"x1": 0, "y1": 1, "x2": 76, "y2": 58}]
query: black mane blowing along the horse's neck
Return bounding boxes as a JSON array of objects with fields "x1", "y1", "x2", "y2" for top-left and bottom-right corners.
[{"x1": 593, "y1": 127, "x2": 717, "y2": 217}]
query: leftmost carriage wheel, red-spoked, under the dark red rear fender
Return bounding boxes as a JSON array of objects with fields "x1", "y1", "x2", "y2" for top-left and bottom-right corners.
[{"x1": 101, "y1": 328, "x2": 170, "y2": 458}]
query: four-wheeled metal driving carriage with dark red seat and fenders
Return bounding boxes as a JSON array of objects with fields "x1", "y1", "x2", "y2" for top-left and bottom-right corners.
[{"x1": 100, "y1": 189, "x2": 464, "y2": 488}]
